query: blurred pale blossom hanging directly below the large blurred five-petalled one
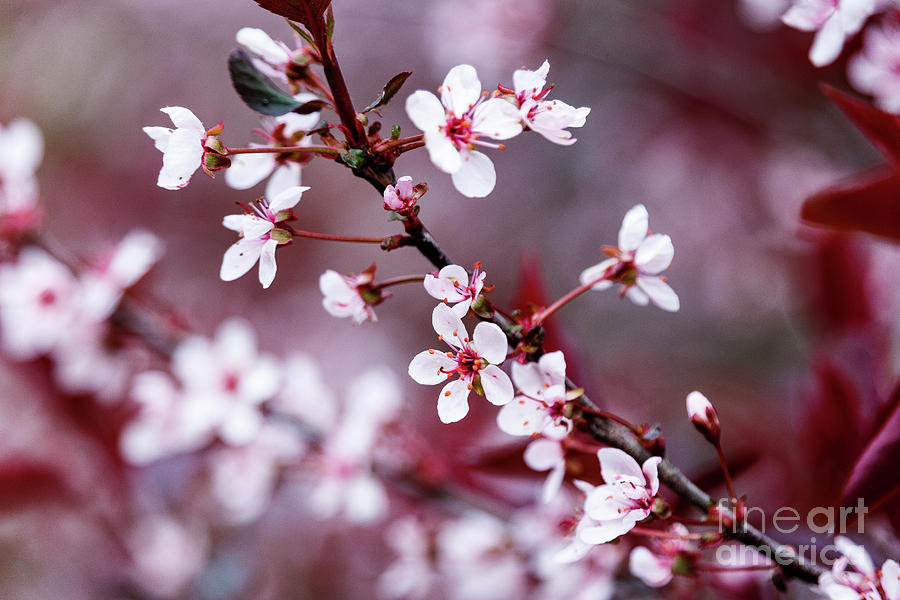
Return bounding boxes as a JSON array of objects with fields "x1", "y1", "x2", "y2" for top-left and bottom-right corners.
[{"x1": 209, "y1": 422, "x2": 306, "y2": 524}]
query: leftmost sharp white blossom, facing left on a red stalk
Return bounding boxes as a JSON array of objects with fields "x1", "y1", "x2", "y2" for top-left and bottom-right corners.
[{"x1": 144, "y1": 106, "x2": 224, "y2": 190}]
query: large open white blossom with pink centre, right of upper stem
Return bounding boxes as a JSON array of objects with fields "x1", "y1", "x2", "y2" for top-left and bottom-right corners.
[{"x1": 406, "y1": 65, "x2": 522, "y2": 198}]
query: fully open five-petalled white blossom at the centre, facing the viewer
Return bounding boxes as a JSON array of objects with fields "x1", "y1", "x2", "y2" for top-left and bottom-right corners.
[{"x1": 409, "y1": 304, "x2": 513, "y2": 423}]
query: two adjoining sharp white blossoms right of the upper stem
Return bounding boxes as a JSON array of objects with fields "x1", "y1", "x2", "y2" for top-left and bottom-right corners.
[{"x1": 406, "y1": 61, "x2": 590, "y2": 198}]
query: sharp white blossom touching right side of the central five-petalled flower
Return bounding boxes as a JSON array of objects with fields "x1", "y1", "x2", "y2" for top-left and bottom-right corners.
[{"x1": 497, "y1": 350, "x2": 572, "y2": 439}]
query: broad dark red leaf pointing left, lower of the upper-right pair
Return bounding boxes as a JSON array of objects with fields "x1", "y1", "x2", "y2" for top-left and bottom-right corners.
[{"x1": 800, "y1": 168, "x2": 900, "y2": 240}]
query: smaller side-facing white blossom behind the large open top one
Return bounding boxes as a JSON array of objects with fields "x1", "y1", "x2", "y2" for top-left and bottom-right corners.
[{"x1": 513, "y1": 60, "x2": 591, "y2": 146}]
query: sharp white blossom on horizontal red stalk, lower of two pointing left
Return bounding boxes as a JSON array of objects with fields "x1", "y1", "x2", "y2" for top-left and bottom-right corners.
[{"x1": 219, "y1": 186, "x2": 309, "y2": 288}]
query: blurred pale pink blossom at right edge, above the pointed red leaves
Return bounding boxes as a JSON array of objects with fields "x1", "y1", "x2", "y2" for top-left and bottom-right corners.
[{"x1": 847, "y1": 22, "x2": 900, "y2": 113}]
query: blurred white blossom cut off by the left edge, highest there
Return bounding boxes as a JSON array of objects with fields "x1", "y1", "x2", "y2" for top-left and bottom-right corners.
[{"x1": 0, "y1": 117, "x2": 44, "y2": 225}]
